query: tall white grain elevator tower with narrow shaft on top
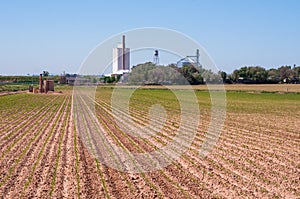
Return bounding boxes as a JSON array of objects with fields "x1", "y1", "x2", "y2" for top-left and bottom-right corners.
[{"x1": 112, "y1": 35, "x2": 130, "y2": 74}]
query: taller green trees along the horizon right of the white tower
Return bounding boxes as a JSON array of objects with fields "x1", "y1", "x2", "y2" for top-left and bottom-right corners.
[{"x1": 128, "y1": 62, "x2": 300, "y2": 85}]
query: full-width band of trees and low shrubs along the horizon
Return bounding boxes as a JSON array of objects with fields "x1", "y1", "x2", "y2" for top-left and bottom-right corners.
[{"x1": 0, "y1": 62, "x2": 300, "y2": 85}]
